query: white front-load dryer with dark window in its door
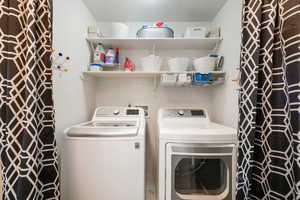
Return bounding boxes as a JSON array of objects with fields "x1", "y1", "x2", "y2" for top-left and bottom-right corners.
[{"x1": 158, "y1": 108, "x2": 237, "y2": 200}]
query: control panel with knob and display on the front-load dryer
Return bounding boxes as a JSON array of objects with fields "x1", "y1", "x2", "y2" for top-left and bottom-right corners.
[{"x1": 162, "y1": 108, "x2": 207, "y2": 118}]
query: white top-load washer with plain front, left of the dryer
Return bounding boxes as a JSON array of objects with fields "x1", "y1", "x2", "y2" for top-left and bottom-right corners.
[{"x1": 63, "y1": 107, "x2": 145, "y2": 200}]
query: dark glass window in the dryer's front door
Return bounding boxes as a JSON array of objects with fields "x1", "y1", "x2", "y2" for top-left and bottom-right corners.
[{"x1": 172, "y1": 156, "x2": 228, "y2": 196}]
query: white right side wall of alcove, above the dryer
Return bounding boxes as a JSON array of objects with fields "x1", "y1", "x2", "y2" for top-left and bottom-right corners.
[{"x1": 211, "y1": 0, "x2": 243, "y2": 127}]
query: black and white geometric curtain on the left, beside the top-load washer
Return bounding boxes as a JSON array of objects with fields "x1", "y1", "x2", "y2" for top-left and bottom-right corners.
[{"x1": 0, "y1": 0, "x2": 60, "y2": 200}]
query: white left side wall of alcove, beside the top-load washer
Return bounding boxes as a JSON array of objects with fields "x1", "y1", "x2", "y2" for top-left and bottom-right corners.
[{"x1": 53, "y1": 0, "x2": 96, "y2": 199}]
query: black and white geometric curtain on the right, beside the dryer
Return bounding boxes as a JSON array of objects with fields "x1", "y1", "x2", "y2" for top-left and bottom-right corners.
[{"x1": 237, "y1": 0, "x2": 300, "y2": 200}]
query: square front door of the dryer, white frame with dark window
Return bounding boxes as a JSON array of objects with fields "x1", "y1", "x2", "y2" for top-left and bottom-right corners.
[{"x1": 166, "y1": 144, "x2": 234, "y2": 200}]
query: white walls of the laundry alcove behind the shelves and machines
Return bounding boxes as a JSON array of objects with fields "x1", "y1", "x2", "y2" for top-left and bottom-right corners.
[{"x1": 53, "y1": 0, "x2": 242, "y2": 200}]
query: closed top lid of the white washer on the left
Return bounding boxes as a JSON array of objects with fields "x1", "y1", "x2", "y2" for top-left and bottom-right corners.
[{"x1": 66, "y1": 121, "x2": 139, "y2": 137}]
